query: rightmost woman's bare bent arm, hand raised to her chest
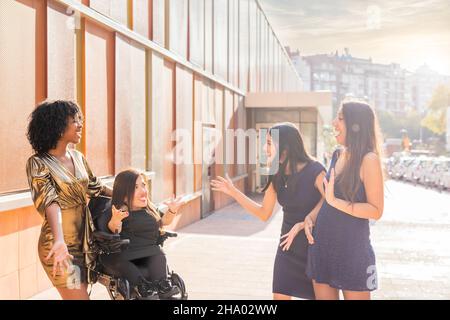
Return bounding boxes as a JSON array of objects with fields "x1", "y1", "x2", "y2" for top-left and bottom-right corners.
[{"x1": 327, "y1": 153, "x2": 384, "y2": 220}]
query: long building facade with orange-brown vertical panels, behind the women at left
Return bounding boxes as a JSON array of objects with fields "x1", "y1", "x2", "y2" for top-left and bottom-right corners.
[{"x1": 0, "y1": 0, "x2": 330, "y2": 299}]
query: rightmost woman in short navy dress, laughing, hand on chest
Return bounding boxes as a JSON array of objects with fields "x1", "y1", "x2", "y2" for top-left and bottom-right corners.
[{"x1": 307, "y1": 102, "x2": 384, "y2": 300}]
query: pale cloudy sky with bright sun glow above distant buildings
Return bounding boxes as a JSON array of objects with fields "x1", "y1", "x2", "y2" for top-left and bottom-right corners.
[{"x1": 259, "y1": 0, "x2": 450, "y2": 75}]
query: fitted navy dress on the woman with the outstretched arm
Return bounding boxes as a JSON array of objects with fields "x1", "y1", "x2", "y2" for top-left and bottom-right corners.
[{"x1": 273, "y1": 161, "x2": 325, "y2": 299}]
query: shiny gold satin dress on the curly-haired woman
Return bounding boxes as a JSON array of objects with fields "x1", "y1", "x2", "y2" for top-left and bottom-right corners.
[{"x1": 27, "y1": 150, "x2": 104, "y2": 288}]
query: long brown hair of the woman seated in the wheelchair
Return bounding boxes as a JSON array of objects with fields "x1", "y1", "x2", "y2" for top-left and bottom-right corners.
[{"x1": 111, "y1": 169, "x2": 161, "y2": 221}]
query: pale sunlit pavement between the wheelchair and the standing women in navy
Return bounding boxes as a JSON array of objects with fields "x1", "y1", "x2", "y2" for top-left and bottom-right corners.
[{"x1": 31, "y1": 196, "x2": 282, "y2": 300}]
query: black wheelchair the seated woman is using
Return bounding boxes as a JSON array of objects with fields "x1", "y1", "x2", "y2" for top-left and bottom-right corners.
[{"x1": 88, "y1": 196, "x2": 188, "y2": 300}]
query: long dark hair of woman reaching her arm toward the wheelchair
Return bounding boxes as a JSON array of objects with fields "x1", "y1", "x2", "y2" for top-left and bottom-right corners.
[{"x1": 263, "y1": 122, "x2": 313, "y2": 192}]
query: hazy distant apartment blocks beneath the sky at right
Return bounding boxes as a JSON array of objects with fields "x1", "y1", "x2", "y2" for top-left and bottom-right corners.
[{"x1": 287, "y1": 48, "x2": 450, "y2": 116}]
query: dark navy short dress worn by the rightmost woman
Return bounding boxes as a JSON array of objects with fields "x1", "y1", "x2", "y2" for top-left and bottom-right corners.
[{"x1": 306, "y1": 150, "x2": 377, "y2": 291}]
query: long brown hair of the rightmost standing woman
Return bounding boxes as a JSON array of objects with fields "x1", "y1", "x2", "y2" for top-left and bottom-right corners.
[{"x1": 336, "y1": 101, "x2": 382, "y2": 203}]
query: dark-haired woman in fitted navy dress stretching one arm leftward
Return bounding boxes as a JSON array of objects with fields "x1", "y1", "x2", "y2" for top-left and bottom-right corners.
[{"x1": 211, "y1": 123, "x2": 325, "y2": 300}]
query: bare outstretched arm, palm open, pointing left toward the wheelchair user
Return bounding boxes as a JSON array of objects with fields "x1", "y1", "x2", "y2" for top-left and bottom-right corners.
[{"x1": 211, "y1": 177, "x2": 277, "y2": 221}]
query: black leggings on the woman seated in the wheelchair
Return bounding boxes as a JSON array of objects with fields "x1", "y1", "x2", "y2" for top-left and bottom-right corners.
[{"x1": 101, "y1": 252, "x2": 167, "y2": 286}]
